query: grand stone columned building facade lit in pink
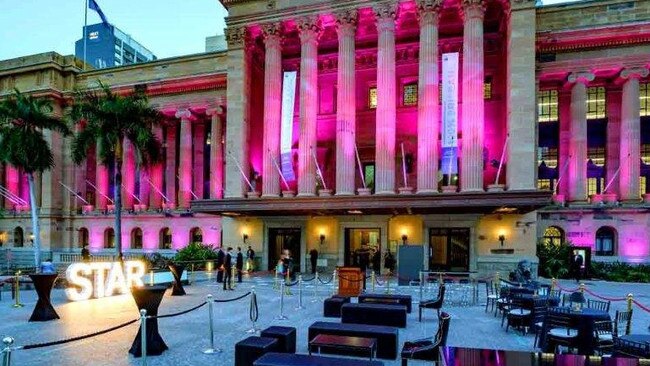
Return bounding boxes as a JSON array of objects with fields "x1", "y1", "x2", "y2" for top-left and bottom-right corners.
[{"x1": 0, "y1": 0, "x2": 650, "y2": 272}]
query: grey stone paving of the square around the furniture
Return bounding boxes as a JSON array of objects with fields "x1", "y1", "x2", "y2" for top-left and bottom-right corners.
[{"x1": 0, "y1": 278, "x2": 650, "y2": 366}]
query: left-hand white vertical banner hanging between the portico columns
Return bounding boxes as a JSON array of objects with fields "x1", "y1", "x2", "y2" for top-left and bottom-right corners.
[{"x1": 280, "y1": 71, "x2": 297, "y2": 181}]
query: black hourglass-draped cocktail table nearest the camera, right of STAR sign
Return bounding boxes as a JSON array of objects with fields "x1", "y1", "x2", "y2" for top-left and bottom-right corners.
[{"x1": 129, "y1": 286, "x2": 168, "y2": 357}]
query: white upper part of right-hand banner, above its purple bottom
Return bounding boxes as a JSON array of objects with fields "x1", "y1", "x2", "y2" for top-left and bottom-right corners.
[{"x1": 442, "y1": 52, "x2": 458, "y2": 148}]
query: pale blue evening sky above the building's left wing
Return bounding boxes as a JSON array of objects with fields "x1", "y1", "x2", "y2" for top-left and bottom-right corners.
[{"x1": 0, "y1": 0, "x2": 581, "y2": 60}]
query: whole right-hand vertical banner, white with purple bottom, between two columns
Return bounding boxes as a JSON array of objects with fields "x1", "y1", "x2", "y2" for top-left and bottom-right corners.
[{"x1": 440, "y1": 52, "x2": 458, "y2": 174}]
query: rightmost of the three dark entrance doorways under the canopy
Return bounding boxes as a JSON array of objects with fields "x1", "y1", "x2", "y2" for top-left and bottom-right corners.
[{"x1": 429, "y1": 228, "x2": 470, "y2": 272}]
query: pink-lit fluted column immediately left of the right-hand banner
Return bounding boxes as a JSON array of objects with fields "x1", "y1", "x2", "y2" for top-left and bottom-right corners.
[{"x1": 417, "y1": 0, "x2": 441, "y2": 193}]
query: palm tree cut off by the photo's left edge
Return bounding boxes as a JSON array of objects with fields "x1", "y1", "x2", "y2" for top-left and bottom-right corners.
[{"x1": 0, "y1": 89, "x2": 70, "y2": 271}]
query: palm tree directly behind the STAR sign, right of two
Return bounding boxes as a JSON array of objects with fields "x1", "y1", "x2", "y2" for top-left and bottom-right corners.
[{"x1": 69, "y1": 83, "x2": 162, "y2": 261}]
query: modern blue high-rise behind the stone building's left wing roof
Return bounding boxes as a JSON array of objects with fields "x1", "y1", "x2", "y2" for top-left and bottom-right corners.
[{"x1": 75, "y1": 23, "x2": 156, "y2": 69}]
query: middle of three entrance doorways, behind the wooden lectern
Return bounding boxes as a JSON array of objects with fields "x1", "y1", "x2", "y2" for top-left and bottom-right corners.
[{"x1": 344, "y1": 228, "x2": 381, "y2": 268}]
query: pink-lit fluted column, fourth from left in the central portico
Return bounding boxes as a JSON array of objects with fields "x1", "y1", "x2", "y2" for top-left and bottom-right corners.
[{"x1": 373, "y1": 2, "x2": 397, "y2": 194}]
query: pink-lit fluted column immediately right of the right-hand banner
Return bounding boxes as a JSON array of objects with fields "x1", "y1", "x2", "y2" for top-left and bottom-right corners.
[{"x1": 460, "y1": 0, "x2": 485, "y2": 192}]
